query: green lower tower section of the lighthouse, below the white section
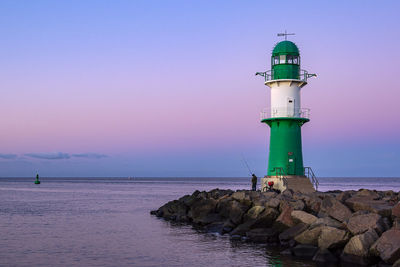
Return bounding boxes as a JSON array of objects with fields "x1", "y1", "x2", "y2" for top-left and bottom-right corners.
[{"x1": 261, "y1": 117, "x2": 309, "y2": 176}]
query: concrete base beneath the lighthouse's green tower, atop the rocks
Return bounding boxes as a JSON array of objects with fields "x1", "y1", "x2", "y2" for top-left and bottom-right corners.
[{"x1": 261, "y1": 175, "x2": 315, "y2": 193}]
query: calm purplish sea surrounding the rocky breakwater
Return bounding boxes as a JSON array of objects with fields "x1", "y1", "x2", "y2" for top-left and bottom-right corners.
[{"x1": 0, "y1": 177, "x2": 400, "y2": 267}]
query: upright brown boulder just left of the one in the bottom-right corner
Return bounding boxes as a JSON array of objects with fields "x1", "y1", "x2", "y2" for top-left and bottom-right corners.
[{"x1": 343, "y1": 229, "x2": 379, "y2": 258}]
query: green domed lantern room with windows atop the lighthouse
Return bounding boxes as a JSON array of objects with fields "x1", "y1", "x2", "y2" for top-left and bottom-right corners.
[{"x1": 271, "y1": 41, "x2": 300, "y2": 80}]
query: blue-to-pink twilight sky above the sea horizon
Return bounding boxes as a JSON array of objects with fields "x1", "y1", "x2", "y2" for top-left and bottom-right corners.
[{"x1": 0, "y1": 0, "x2": 400, "y2": 177}]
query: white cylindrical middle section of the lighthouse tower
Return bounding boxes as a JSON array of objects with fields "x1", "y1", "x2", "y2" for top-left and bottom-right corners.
[{"x1": 265, "y1": 79, "x2": 307, "y2": 118}]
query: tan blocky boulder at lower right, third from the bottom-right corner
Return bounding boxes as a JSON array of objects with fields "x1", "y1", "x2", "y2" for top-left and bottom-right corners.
[{"x1": 318, "y1": 226, "x2": 350, "y2": 249}]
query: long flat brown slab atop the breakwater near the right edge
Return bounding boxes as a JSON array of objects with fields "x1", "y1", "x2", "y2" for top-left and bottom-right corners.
[{"x1": 345, "y1": 195, "x2": 393, "y2": 217}]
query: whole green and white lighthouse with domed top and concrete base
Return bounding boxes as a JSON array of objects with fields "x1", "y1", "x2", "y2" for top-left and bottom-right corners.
[{"x1": 256, "y1": 33, "x2": 318, "y2": 192}]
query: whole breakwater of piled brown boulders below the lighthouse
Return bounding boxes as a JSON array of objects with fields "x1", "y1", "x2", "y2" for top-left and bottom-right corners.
[{"x1": 151, "y1": 189, "x2": 400, "y2": 266}]
